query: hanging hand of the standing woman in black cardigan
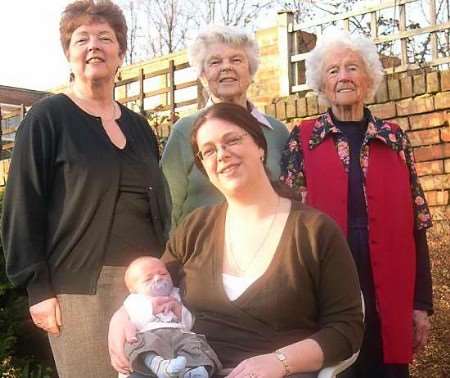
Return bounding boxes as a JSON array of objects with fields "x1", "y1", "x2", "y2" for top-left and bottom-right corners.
[{"x1": 30, "y1": 297, "x2": 62, "y2": 336}]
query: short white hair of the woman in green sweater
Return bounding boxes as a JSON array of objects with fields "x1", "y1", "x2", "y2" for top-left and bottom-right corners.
[{"x1": 188, "y1": 25, "x2": 259, "y2": 77}]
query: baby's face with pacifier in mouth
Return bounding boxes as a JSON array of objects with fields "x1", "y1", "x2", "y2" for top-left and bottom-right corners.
[{"x1": 133, "y1": 260, "x2": 173, "y2": 297}]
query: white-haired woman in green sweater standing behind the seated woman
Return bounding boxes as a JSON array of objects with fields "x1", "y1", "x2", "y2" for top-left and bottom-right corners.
[{"x1": 161, "y1": 25, "x2": 289, "y2": 227}]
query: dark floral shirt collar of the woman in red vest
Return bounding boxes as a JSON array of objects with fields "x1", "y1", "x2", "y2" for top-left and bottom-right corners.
[{"x1": 309, "y1": 108, "x2": 402, "y2": 151}]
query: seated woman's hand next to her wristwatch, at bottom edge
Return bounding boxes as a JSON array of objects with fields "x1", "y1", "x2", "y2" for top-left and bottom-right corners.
[{"x1": 228, "y1": 354, "x2": 285, "y2": 378}]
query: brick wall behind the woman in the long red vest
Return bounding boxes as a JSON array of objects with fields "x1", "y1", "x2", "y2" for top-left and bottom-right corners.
[{"x1": 265, "y1": 70, "x2": 450, "y2": 220}]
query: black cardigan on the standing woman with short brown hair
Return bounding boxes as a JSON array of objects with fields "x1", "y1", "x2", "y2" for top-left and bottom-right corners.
[{"x1": 2, "y1": 94, "x2": 170, "y2": 304}]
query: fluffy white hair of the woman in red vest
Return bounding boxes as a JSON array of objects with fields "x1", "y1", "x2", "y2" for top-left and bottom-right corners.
[{"x1": 305, "y1": 28, "x2": 384, "y2": 105}]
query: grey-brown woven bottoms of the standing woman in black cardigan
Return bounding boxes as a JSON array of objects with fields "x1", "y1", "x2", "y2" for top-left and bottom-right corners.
[{"x1": 49, "y1": 266, "x2": 128, "y2": 378}]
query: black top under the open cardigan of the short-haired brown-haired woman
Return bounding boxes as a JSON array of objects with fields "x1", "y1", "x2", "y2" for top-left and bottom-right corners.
[{"x1": 103, "y1": 141, "x2": 161, "y2": 266}]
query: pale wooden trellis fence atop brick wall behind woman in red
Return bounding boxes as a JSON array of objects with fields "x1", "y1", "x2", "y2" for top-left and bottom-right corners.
[{"x1": 279, "y1": 0, "x2": 450, "y2": 96}]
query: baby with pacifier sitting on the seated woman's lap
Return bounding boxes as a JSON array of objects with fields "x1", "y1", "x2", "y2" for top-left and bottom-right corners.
[{"x1": 124, "y1": 257, "x2": 221, "y2": 378}]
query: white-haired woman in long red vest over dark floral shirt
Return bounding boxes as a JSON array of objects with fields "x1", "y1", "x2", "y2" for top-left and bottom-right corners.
[{"x1": 281, "y1": 29, "x2": 433, "y2": 378}]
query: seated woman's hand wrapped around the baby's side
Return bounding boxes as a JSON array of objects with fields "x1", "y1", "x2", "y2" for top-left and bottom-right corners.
[{"x1": 108, "y1": 307, "x2": 137, "y2": 374}]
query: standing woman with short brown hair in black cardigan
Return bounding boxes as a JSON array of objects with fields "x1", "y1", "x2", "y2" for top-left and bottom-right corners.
[{"x1": 2, "y1": 0, "x2": 169, "y2": 377}]
